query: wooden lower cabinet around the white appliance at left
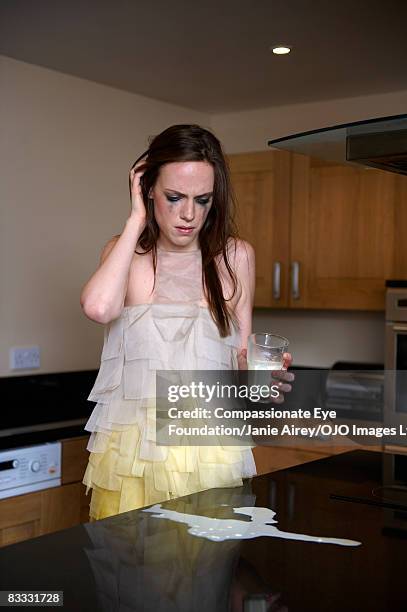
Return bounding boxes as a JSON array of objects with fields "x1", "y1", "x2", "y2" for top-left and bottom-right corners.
[{"x1": 0, "y1": 436, "x2": 90, "y2": 546}]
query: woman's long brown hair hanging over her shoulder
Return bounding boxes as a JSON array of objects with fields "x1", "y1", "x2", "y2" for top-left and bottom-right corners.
[{"x1": 132, "y1": 125, "x2": 237, "y2": 337}]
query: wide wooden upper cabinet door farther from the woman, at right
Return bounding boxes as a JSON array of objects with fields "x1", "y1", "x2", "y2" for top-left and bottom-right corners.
[{"x1": 290, "y1": 154, "x2": 407, "y2": 310}]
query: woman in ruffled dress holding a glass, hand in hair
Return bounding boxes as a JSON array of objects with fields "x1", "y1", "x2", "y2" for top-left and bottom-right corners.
[{"x1": 81, "y1": 125, "x2": 290, "y2": 519}]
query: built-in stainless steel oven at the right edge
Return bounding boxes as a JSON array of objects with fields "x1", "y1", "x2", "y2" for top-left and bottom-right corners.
[{"x1": 385, "y1": 281, "x2": 407, "y2": 438}]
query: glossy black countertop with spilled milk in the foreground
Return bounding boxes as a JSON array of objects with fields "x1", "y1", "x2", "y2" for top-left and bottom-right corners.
[{"x1": 0, "y1": 451, "x2": 407, "y2": 612}]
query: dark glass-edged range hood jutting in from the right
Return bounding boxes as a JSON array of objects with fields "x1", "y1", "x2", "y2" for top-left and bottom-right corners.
[{"x1": 268, "y1": 115, "x2": 407, "y2": 174}]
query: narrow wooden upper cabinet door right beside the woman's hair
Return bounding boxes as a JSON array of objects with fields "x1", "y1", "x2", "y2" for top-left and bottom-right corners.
[{"x1": 229, "y1": 151, "x2": 291, "y2": 308}]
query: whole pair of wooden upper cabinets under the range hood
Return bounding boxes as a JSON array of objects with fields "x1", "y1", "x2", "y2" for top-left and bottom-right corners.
[{"x1": 229, "y1": 151, "x2": 407, "y2": 310}]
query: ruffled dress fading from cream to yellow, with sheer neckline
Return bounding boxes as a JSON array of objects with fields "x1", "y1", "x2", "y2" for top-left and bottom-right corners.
[{"x1": 83, "y1": 249, "x2": 256, "y2": 519}]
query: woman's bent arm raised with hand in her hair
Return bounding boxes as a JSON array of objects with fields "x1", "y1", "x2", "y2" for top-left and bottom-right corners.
[{"x1": 81, "y1": 162, "x2": 146, "y2": 324}]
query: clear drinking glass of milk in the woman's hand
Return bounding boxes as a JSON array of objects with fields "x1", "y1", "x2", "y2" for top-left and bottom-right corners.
[{"x1": 247, "y1": 332, "x2": 289, "y2": 400}]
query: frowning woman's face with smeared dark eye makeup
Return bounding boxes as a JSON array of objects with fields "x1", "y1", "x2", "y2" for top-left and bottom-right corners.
[{"x1": 150, "y1": 161, "x2": 214, "y2": 251}]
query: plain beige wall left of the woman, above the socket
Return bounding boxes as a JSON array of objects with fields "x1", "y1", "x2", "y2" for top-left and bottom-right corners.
[{"x1": 0, "y1": 56, "x2": 209, "y2": 376}]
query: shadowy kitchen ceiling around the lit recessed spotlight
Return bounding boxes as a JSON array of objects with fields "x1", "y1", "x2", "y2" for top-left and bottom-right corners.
[{"x1": 0, "y1": 0, "x2": 407, "y2": 113}]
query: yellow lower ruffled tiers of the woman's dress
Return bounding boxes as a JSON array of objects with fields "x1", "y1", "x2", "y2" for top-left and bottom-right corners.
[{"x1": 83, "y1": 425, "x2": 254, "y2": 520}]
